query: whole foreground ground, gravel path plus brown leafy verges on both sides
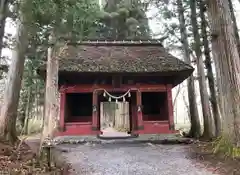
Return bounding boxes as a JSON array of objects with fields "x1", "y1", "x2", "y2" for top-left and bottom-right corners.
[{"x1": 3, "y1": 135, "x2": 240, "y2": 175}]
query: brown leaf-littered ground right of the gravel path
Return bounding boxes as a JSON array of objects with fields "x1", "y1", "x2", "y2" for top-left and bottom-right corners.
[{"x1": 190, "y1": 142, "x2": 240, "y2": 175}]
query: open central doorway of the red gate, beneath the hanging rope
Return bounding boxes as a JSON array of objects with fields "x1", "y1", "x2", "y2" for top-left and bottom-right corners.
[{"x1": 99, "y1": 93, "x2": 132, "y2": 138}]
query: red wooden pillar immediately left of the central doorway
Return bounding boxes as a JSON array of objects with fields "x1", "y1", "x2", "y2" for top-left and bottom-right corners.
[{"x1": 92, "y1": 91, "x2": 99, "y2": 133}]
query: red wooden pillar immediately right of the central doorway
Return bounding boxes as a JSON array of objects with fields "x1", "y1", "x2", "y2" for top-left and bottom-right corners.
[{"x1": 136, "y1": 91, "x2": 144, "y2": 131}]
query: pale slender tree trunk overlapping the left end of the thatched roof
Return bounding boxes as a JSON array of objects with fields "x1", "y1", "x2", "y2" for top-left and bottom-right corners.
[{"x1": 41, "y1": 32, "x2": 59, "y2": 145}]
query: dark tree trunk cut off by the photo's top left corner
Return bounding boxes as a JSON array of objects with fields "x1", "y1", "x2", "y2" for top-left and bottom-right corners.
[{"x1": 0, "y1": 0, "x2": 9, "y2": 55}]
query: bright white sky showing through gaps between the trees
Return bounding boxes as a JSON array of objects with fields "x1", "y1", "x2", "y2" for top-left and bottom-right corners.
[{"x1": 2, "y1": 0, "x2": 240, "y2": 123}]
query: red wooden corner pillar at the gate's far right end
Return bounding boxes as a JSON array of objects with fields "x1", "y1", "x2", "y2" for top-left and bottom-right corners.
[{"x1": 167, "y1": 84, "x2": 175, "y2": 130}]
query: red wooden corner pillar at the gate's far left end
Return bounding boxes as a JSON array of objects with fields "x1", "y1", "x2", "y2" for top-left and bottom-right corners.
[{"x1": 59, "y1": 89, "x2": 66, "y2": 131}]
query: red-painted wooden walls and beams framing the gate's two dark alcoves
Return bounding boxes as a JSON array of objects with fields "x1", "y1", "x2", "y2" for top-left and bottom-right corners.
[{"x1": 56, "y1": 84, "x2": 174, "y2": 135}]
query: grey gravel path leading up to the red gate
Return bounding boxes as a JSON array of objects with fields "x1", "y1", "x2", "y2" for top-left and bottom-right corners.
[{"x1": 56, "y1": 143, "x2": 216, "y2": 175}]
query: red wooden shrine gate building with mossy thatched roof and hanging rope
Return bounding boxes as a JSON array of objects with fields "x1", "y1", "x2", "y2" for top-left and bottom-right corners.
[{"x1": 40, "y1": 40, "x2": 194, "y2": 136}]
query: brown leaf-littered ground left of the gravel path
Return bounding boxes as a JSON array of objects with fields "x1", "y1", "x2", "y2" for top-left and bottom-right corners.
[{"x1": 0, "y1": 137, "x2": 66, "y2": 175}]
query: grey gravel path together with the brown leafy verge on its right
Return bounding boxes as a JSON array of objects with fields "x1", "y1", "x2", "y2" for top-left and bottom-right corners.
[{"x1": 55, "y1": 139, "x2": 240, "y2": 175}]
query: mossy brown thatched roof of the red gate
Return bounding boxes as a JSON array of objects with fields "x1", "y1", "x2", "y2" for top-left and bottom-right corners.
[{"x1": 38, "y1": 40, "x2": 193, "y2": 84}]
